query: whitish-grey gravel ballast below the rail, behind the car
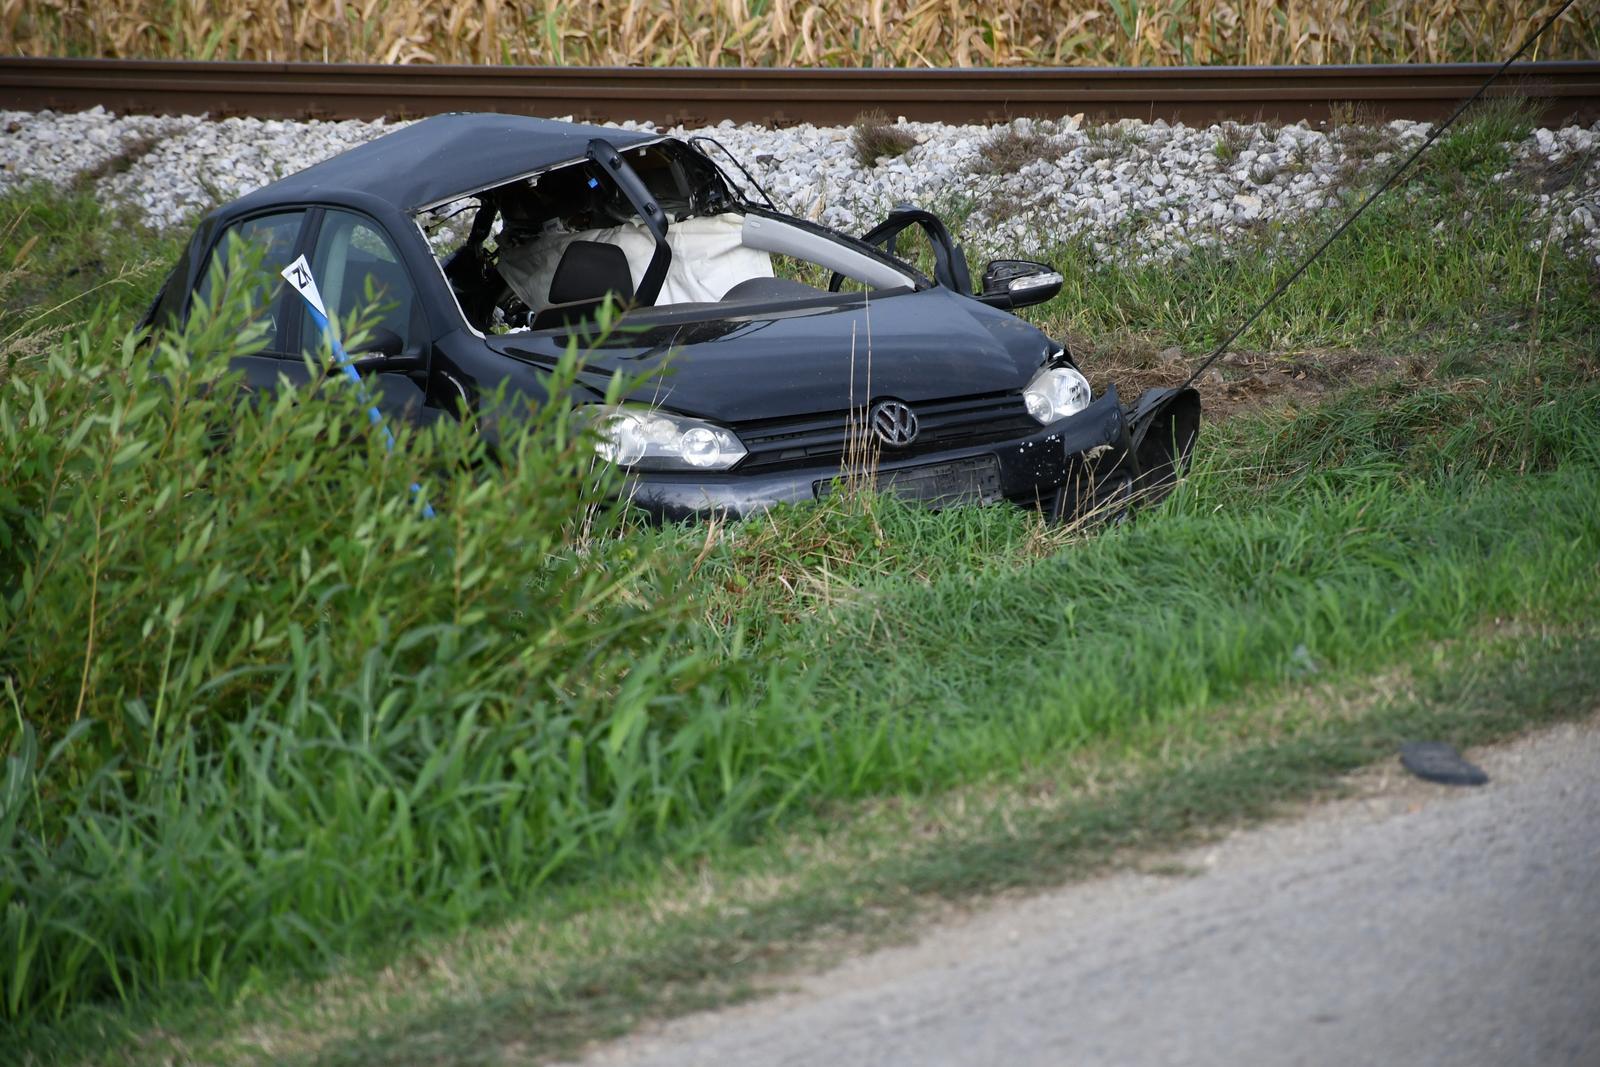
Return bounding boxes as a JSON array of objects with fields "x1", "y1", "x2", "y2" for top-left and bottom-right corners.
[{"x1": 0, "y1": 109, "x2": 1600, "y2": 264}]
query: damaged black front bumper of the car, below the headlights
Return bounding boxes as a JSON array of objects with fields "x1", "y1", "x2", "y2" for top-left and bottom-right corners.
[{"x1": 624, "y1": 387, "x2": 1130, "y2": 522}]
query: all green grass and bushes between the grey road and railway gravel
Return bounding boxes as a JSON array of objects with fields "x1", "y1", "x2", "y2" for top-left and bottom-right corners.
[{"x1": 9, "y1": 112, "x2": 1600, "y2": 1062}]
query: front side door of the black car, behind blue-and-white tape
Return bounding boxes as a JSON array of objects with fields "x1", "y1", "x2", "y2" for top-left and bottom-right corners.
[{"x1": 299, "y1": 208, "x2": 442, "y2": 422}]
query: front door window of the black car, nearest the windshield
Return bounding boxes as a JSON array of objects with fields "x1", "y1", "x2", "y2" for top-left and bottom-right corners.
[{"x1": 301, "y1": 208, "x2": 427, "y2": 352}]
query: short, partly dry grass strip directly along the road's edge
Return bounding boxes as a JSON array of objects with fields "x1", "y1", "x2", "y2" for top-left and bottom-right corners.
[{"x1": 43, "y1": 622, "x2": 1600, "y2": 1065}]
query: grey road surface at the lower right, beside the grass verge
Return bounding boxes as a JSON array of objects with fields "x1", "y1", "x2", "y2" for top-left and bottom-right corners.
[{"x1": 586, "y1": 718, "x2": 1600, "y2": 1067}]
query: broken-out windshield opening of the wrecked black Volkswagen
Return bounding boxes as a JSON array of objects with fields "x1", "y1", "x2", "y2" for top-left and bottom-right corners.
[{"x1": 419, "y1": 139, "x2": 915, "y2": 334}]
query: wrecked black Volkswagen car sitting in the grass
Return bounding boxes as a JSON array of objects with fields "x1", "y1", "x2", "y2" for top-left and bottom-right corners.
[{"x1": 147, "y1": 114, "x2": 1200, "y2": 520}]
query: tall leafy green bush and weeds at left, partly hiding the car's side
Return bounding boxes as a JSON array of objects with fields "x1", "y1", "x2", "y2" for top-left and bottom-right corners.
[{"x1": 0, "y1": 255, "x2": 755, "y2": 1025}]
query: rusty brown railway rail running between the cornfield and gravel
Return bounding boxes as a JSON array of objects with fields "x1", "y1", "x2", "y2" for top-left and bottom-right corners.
[{"x1": 0, "y1": 58, "x2": 1600, "y2": 126}]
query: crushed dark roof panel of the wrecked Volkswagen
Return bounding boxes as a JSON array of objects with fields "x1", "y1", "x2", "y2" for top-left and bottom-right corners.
[{"x1": 228, "y1": 114, "x2": 661, "y2": 211}]
